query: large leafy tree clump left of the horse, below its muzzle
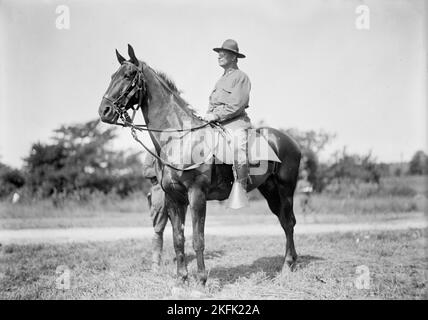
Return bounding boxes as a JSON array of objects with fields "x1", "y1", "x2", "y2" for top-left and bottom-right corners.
[{"x1": 0, "y1": 120, "x2": 148, "y2": 198}]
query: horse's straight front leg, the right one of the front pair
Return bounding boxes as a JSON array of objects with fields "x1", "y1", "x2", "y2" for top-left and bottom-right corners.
[{"x1": 189, "y1": 187, "x2": 207, "y2": 285}]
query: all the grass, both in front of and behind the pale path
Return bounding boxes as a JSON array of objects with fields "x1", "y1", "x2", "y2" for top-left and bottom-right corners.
[{"x1": 0, "y1": 177, "x2": 428, "y2": 299}]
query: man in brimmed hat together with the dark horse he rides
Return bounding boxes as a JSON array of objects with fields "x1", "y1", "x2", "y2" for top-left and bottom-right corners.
[{"x1": 98, "y1": 40, "x2": 301, "y2": 284}]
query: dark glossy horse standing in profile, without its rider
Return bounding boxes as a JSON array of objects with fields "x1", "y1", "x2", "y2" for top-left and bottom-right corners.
[{"x1": 98, "y1": 45, "x2": 301, "y2": 284}]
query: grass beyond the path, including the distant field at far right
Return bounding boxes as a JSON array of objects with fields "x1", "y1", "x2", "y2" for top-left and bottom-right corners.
[{"x1": 0, "y1": 176, "x2": 428, "y2": 229}]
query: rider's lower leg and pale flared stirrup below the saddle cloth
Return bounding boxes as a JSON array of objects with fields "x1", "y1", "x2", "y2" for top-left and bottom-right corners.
[{"x1": 227, "y1": 163, "x2": 249, "y2": 209}]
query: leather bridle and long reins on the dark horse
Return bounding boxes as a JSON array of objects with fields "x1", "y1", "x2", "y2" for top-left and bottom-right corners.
[{"x1": 103, "y1": 61, "x2": 224, "y2": 171}]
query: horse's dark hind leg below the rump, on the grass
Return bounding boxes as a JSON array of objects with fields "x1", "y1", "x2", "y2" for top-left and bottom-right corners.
[{"x1": 258, "y1": 176, "x2": 297, "y2": 270}]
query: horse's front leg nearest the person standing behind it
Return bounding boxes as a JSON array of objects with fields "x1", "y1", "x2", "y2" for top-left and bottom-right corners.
[{"x1": 168, "y1": 201, "x2": 187, "y2": 282}]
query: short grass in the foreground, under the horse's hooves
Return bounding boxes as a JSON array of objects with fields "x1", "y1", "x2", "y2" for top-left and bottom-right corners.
[{"x1": 0, "y1": 230, "x2": 428, "y2": 299}]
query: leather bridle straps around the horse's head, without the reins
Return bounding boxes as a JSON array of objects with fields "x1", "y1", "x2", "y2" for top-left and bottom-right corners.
[{"x1": 103, "y1": 61, "x2": 146, "y2": 122}]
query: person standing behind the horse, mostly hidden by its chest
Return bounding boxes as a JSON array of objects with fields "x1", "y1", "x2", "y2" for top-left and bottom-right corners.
[{"x1": 144, "y1": 154, "x2": 168, "y2": 271}]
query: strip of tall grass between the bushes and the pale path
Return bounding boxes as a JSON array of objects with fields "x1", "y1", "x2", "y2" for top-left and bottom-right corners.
[{"x1": 0, "y1": 195, "x2": 426, "y2": 229}]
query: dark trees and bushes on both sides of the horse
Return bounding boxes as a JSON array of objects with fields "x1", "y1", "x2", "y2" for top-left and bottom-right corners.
[{"x1": 0, "y1": 120, "x2": 428, "y2": 200}]
